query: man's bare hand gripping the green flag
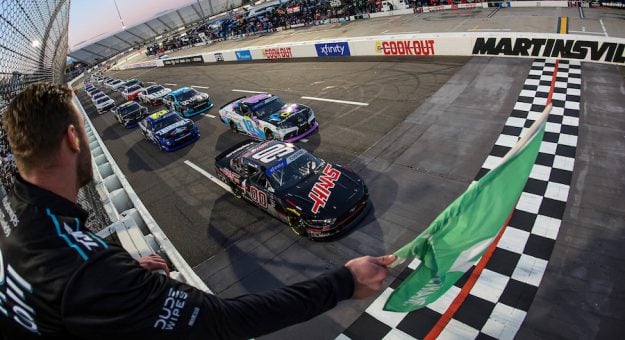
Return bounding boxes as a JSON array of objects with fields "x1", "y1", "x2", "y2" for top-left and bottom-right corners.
[{"x1": 345, "y1": 255, "x2": 397, "y2": 299}]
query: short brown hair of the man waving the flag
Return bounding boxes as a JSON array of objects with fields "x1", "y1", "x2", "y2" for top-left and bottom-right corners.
[{"x1": 2, "y1": 83, "x2": 79, "y2": 170}]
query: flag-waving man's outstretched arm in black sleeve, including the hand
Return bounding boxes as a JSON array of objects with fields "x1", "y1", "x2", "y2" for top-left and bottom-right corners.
[{"x1": 63, "y1": 246, "x2": 394, "y2": 339}]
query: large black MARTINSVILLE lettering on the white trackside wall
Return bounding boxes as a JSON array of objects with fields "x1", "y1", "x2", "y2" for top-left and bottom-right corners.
[{"x1": 473, "y1": 38, "x2": 625, "y2": 64}]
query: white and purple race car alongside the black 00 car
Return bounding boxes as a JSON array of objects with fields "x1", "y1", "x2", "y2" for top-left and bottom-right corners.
[{"x1": 219, "y1": 93, "x2": 319, "y2": 142}]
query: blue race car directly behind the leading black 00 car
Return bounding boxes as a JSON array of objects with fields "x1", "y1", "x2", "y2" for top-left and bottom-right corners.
[{"x1": 139, "y1": 110, "x2": 200, "y2": 151}]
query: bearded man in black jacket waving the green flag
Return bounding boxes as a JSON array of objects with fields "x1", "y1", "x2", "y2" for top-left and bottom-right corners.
[{"x1": 0, "y1": 84, "x2": 395, "y2": 340}]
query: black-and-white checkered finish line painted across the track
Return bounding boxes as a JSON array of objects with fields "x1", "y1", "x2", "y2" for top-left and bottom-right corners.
[{"x1": 337, "y1": 60, "x2": 581, "y2": 340}]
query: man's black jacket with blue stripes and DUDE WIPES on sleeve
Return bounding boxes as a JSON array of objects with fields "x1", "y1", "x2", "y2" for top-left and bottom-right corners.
[{"x1": 0, "y1": 177, "x2": 354, "y2": 340}]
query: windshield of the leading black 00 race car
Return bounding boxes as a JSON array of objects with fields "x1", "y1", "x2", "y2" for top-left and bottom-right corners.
[{"x1": 266, "y1": 149, "x2": 325, "y2": 188}]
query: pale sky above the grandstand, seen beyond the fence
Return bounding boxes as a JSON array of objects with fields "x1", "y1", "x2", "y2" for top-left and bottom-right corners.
[{"x1": 68, "y1": 0, "x2": 197, "y2": 51}]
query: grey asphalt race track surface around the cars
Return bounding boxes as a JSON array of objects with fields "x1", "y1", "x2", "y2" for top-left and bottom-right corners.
[{"x1": 81, "y1": 9, "x2": 625, "y2": 339}]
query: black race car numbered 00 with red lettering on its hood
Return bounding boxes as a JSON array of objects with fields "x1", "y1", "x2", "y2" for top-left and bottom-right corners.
[{"x1": 215, "y1": 140, "x2": 371, "y2": 239}]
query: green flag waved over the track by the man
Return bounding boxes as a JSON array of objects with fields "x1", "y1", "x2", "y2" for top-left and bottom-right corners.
[{"x1": 384, "y1": 105, "x2": 551, "y2": 312}]
